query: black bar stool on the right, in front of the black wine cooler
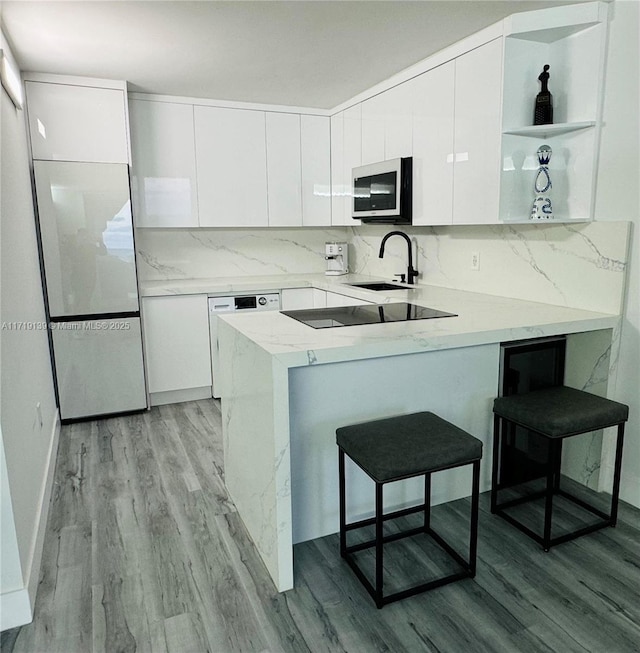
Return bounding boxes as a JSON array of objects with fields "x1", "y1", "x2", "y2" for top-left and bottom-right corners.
[{"x1": 491, "y1": 386, "x2": 629, "y2": 551}]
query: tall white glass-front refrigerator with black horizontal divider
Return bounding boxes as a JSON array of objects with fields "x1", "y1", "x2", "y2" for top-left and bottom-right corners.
[{"x1": 34, "y1": 161, "x2": 147, "y2": 421}]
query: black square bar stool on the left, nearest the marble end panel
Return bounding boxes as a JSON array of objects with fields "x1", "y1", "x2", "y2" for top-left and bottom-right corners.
[{"x1": 336, "y1": 412, "x2": 482, "y2": 608}]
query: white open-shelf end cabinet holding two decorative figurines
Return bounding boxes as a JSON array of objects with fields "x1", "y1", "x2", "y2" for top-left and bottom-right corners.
[{"x1": 500, "y1": 2, "x2": 607, "y2": 221}]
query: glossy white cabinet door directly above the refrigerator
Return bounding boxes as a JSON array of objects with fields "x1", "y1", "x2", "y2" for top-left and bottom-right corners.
[{"x1": 25, "y1": 82, "x2": 129, "y2": 163}]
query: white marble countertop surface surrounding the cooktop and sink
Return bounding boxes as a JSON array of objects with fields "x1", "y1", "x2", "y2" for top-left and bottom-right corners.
[{"x1": 168, "y1": 274, "x2": 620, "y2": 367}]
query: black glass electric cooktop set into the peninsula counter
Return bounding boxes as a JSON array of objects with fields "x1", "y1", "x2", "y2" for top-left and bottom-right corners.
[{"x1": 280, "y1": 302, "x2": 457, "y2": 329}]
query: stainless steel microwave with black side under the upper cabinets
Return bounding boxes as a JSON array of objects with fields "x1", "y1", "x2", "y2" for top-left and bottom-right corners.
[{"x1": 351, "y1": 156, "x2": 413, "y2": 224}]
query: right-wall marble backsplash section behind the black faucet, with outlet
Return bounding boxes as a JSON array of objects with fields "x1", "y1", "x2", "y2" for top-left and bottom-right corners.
[{"x1": 351, "y1": 222, "x2": 630, "y2": 313}]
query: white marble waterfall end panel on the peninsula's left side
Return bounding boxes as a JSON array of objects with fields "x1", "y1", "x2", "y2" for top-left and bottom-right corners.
[{"x1": 219, "y1": 321, "x2": 293, "y2": 592}]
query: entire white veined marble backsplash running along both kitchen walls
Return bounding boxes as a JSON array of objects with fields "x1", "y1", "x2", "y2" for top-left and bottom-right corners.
[{"x1": 136, "y1": 222, "x2": 630, "y2": 313}]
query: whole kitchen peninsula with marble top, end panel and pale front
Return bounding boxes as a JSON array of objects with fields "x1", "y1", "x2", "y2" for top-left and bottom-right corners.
[{"x1": 219, "y1": 278, "x2": 620, "y2": 591}]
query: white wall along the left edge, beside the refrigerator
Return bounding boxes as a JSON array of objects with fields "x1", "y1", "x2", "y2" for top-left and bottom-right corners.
[{"x1": 0, "y1": 33, "x2": 59, "y2": 629}]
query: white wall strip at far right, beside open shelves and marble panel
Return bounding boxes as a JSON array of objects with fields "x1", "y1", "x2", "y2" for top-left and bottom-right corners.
[{"x1": 595, "y1": 0, "x2": 640, "y2": 506}]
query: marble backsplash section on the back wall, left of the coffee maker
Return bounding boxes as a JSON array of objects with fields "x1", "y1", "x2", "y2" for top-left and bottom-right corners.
[{"x1": 136, "y1": 228, "x2": 347, "y2": 281}]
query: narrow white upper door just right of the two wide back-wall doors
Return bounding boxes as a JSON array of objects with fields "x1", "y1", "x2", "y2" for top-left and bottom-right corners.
[{"x1": 266, "y1": 112, "x2": 302, "y2": 227}]
